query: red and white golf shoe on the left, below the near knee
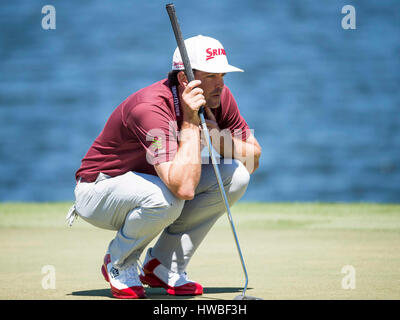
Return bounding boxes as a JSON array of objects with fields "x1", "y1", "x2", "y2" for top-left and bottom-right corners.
[{"x1": 101, "y1": 254, "x2": 146, "y2": 299}]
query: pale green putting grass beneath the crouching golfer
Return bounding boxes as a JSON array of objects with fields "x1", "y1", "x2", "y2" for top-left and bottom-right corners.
[{"x1": 0, "y1": 203, "x2": 400, "y2": 299}]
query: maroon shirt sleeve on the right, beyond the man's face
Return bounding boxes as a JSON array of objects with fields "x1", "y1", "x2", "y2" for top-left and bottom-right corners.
[{"x1": 218, "y1": 86, "x2": 251, "y2": 141}]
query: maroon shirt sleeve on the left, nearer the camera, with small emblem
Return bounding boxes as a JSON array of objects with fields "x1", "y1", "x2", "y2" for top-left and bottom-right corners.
[{"x1": 125, "y1": 103, "x2": 178, "y2": 165}]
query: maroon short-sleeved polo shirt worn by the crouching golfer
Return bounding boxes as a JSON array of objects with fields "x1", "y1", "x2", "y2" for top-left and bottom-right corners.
[{"x1": 75, "y1": 79, "x2": 250, "y2": 182}]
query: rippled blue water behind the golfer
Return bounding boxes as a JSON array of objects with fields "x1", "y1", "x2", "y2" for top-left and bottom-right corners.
[{"x1": 0, "y1": 0, "x2": 400, "y2": 202}]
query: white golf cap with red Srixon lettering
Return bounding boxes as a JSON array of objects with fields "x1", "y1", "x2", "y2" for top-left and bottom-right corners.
[{"x1": 172, "y1": 35, "x2": 243, "y2": 73}]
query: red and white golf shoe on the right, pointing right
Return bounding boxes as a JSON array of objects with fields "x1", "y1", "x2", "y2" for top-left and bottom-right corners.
[{"x1": 139, "y1": 248, "x2": 203, "y2": 296}]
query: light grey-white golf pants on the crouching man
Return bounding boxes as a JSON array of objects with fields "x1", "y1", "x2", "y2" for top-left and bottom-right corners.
[{"x1": 75, "y1": 160, "x2": 250, "y2": 272}]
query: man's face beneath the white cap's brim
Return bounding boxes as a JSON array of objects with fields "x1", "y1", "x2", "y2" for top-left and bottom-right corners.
[{"x1": 194, "y1": 70, "x2": 225, "y2": 109}]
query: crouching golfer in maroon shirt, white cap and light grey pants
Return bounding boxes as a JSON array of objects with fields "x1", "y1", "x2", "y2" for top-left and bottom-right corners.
[{"x1": 67, "y1": 35, "x2": 261, "y2": 299}]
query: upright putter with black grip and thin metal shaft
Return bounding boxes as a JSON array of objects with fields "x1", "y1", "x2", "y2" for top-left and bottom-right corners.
[{"x1": 166, "y1": 3, "x2": 262, "y2": 300}]
